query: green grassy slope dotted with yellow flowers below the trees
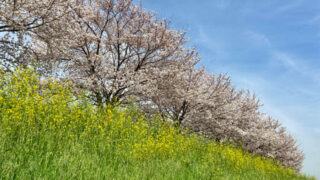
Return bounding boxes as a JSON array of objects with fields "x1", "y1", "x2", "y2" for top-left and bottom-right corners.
[{"x1": 0, "y1": 69, "x2": 312, "y2": 179}]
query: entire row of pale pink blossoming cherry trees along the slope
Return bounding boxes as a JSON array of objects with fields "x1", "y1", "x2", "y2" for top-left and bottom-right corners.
[{"x1": 0, "y1": 0, "x2": 303, "y2": 171}]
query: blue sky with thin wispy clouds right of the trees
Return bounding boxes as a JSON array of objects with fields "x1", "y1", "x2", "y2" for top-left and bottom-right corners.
[{"x1": 141, "y1": 0, "x2": 320, "y2": 178}]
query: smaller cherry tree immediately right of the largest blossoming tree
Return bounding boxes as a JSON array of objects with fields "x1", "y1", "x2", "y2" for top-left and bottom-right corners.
[{"x1": 135, "y1": 64, "x2": 242, "y2": 126}]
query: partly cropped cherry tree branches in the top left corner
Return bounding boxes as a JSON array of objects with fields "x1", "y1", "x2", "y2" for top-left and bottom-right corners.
[{"x1": 0, "y1": 0, "x2": 69, "y2": 70}]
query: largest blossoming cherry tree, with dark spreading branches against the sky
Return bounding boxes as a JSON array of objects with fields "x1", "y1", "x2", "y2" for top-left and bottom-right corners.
[{"x1": 29, "y1": 0, "x2": 198, "y2": 104}]
